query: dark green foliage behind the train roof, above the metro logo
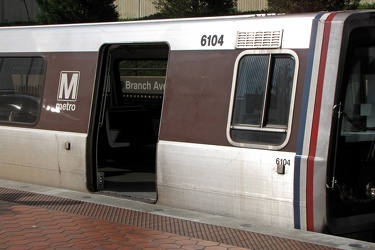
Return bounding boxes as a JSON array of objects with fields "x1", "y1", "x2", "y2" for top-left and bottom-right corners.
[{"x1": 37, "y1": 0, "x2": 119, "y2": 24}]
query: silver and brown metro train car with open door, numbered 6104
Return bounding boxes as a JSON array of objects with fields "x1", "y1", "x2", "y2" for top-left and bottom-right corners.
[{"x1": 0, "y1": 11, "x2": 375, "y2": 241}]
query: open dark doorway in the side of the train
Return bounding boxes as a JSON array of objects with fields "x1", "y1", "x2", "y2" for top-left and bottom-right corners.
[{"x1": 93, "y1": 43, "x2": 169, "y2": 202}]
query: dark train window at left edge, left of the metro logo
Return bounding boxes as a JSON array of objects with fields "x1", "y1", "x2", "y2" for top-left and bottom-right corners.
[{"x1": 0, "y1": 57, "x2": 45, "y2": 124}]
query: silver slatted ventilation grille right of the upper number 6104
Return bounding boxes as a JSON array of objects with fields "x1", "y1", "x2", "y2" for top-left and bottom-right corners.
[{"x1": 236, "y1": 30, "x2": 283, "y2": 49}]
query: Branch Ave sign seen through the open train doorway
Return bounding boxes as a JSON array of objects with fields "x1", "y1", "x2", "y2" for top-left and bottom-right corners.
[{"x1": 121, "y1": 76, "x2": 165, "y2": 94}]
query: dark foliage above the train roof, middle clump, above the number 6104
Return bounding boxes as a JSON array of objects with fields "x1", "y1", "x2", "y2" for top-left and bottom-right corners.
[{"x1": 153, "y1": 0, "x2": 237, "y2": 18}]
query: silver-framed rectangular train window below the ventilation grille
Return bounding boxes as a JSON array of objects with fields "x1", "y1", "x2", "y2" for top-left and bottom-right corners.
[{"x1": 228, "y1": 49, "x2": 298, "y2": 149}]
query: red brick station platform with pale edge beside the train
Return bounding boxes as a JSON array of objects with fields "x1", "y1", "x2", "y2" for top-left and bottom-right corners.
[{"x1": 0, "y1": 180, "x2": 375, "y2": 250}]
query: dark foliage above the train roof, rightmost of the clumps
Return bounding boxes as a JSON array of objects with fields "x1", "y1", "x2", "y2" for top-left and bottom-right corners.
[{"x1": 268, "y1": 0, "x2": 360, "y2": 13}]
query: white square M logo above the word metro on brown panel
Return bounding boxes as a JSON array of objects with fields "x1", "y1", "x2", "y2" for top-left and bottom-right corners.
[{"x1": 57, "y1": 71, "x2": 80, "y2": 101}]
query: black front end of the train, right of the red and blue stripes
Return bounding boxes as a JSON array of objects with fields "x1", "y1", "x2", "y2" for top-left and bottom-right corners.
[{"x1": 327, "y1": 13, "x2": 375, "y2": 242}]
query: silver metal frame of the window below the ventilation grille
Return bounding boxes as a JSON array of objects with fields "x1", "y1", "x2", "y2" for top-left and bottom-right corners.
[{"x1": 226, "y1": 49, "x2": 299, "y2": 150}]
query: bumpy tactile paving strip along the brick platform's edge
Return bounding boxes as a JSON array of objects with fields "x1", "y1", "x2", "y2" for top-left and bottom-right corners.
[{"x1": 0, "y1": 188, "x2": 335, "y2": 250}]
